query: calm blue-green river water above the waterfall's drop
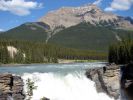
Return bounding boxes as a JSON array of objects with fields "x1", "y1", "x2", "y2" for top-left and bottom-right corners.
[{"x1": 0, "y1": 62, "x2": 105, "y2": 75}]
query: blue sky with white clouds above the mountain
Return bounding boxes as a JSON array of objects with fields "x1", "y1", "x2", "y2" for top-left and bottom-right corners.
[{"x1": 0, "y1": 0, "x2": 133, "y2": 31}]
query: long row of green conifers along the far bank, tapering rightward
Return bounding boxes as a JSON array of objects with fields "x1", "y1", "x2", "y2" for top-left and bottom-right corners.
[{"x1": 0, "y1": 39, "x2": 107, "y2": 64}]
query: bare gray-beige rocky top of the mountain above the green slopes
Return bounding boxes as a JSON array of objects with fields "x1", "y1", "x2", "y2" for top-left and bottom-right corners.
[{"x1": 39, "y1": 4, "x2": 133, "y2": 29}]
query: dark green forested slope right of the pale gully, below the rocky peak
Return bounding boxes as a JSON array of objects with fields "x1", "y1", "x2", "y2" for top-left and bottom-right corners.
[{"x1": 48, "y1": 22, "x2": 133, "y2": 51}]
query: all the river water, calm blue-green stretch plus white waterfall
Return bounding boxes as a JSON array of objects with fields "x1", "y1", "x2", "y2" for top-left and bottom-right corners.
[{"x1": 0, "y1": 63, "x2": 114, "y2": 100}]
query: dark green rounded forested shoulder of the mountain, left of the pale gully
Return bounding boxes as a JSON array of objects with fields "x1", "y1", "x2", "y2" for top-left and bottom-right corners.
[{"x1": 0, "y1": 22, "x2": 50, "y2": 41}]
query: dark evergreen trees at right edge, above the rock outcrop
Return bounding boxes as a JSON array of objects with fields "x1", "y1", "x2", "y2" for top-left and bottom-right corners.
[{"x1": 108, "y1": 37, "x2": 133, "y2": 64}]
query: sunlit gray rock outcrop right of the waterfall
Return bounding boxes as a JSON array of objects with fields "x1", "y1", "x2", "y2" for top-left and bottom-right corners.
[{"x1": 86, "y1": 65, "x2": 120, "y2": 99}]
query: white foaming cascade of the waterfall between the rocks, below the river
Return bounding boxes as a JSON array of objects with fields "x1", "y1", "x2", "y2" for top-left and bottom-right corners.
[{"x1": 22, "y1": 73, "x2": 113, "y2": 100}]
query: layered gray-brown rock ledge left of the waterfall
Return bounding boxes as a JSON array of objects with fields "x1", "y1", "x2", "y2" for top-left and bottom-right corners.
[{"x1": 0, "y1": 73, "x2": 25, "y2": 100}]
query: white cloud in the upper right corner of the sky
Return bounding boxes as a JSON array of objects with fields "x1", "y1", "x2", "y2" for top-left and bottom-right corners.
[{"x1": 105, "y1": 0, "x2": 133, "y2": 11}]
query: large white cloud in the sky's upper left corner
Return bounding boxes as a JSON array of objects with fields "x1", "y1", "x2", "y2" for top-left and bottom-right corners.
[{"x1": 0, "y1": 0, "x2": 42, "y2": 16}]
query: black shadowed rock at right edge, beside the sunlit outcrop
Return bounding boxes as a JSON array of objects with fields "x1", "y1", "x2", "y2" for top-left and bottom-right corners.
[{"x1": 121, "y1": 63, "x2": 133, "y2": 100}]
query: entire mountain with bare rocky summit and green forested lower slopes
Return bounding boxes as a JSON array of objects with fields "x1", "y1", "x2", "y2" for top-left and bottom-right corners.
[{"x1": 0, "y1": 4, "x2": 133, "y2": 51}]
